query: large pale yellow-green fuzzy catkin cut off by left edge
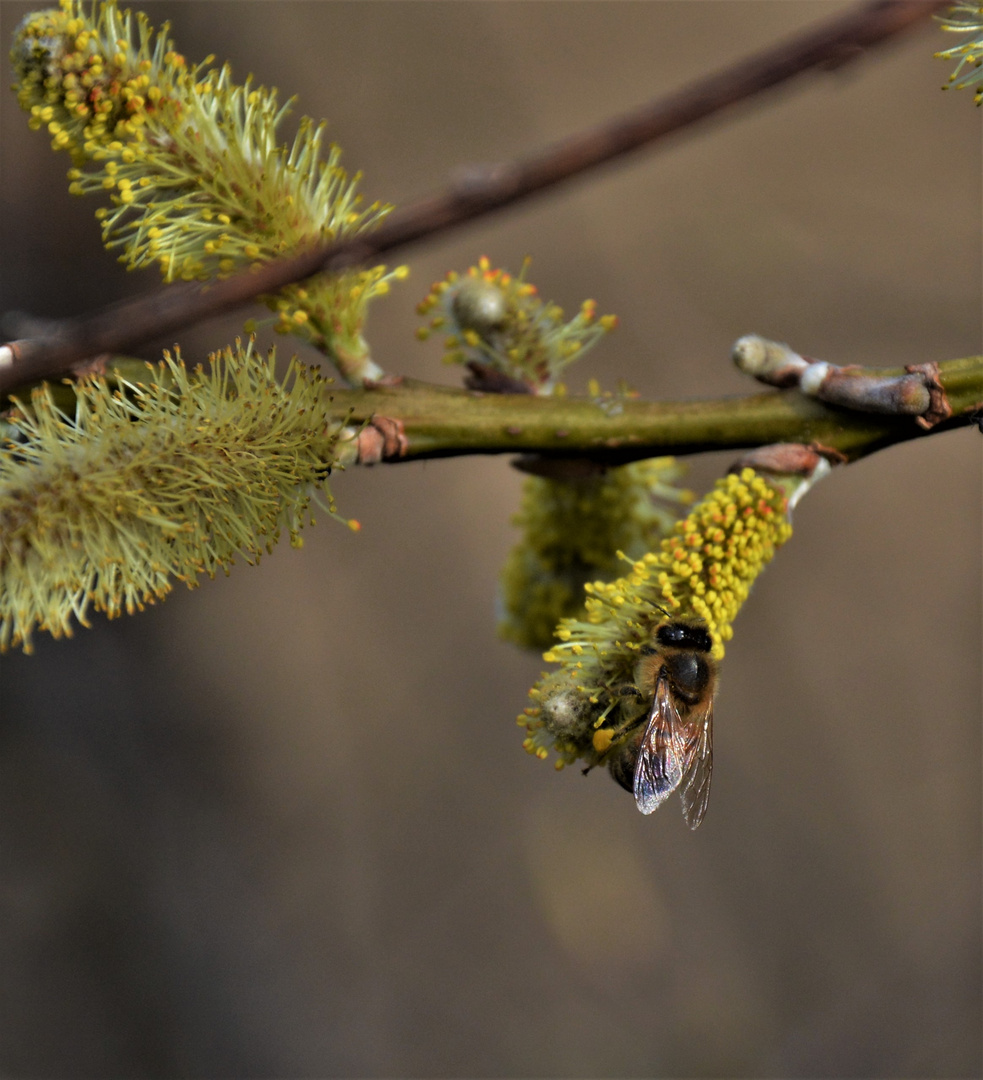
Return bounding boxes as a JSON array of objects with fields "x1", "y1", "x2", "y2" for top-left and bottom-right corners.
[{"x1": 0, "y1": 342, "x2": 341, "y2": 652}]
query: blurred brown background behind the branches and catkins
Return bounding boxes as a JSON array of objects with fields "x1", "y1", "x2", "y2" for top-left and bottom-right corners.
[{"x1": 0, "y1": 0, "x2": 981, "y2": 1077}]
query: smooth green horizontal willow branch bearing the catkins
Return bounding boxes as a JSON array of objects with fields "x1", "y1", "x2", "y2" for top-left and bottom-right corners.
[{"x1": 332, "y1": 356, "x2": 983, "y2": 465}]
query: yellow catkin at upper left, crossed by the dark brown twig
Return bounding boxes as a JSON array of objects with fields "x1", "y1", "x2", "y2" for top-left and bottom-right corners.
[{"x1": 11, "y1": 0, "x2": 407, "y2": 380}]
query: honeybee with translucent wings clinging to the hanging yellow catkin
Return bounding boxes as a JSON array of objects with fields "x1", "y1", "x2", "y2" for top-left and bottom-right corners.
[{"x1": 608, "y1": 612, "x2": 717, "y2": 828}]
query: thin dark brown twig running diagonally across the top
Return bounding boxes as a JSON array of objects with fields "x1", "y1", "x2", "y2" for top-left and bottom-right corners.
[{"x1": 0, "y1": 0, "x2": 947, "y2": 394}]
